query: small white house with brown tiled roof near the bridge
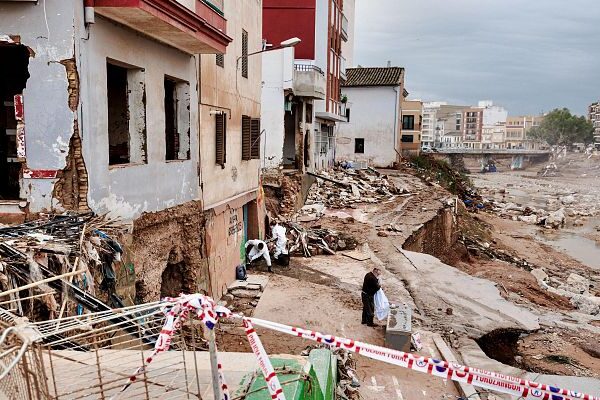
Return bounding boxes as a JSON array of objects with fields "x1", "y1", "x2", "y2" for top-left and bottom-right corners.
[{"x1": 336, "y1": 67, "x2": 408, "y2": 167}]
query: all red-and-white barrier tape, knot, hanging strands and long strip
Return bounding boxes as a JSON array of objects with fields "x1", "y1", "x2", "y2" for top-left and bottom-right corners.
[{"x1": 111, "y1": 294, "x2": 600, "y2": 400}]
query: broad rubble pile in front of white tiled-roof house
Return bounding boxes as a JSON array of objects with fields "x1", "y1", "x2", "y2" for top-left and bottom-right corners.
[{"x1": 306, "y1": 168, "x2": 407, "y2": 209}]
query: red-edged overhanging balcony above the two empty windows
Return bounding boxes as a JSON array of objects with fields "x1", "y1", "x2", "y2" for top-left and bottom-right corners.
[{"x1": 94, "y1": 0, "x2": 232, "y2": 54}]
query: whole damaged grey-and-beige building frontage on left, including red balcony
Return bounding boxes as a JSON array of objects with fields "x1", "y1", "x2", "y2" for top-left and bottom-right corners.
[{"x1": 0, "y1": 0, "x2": 264, "y2": 300}]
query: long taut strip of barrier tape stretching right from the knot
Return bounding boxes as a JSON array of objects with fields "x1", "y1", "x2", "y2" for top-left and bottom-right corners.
[{"x1": 248, "y1": 318, "x2": 600, "y2": 400}]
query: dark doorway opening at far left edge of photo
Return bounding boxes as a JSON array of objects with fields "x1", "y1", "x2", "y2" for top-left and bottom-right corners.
[{"x1": 0, "y1": 42, "x2": 29, "y2": 200}]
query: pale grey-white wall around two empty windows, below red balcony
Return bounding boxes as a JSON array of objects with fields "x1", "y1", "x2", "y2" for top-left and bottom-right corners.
[{"x1": 80, "y1": 18, "x2": 199, "y2": 220}]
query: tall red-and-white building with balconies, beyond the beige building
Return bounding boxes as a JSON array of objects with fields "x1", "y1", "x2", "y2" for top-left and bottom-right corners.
[{"x1": 261, "y1": 0, "x2": 354, "y2": 171}]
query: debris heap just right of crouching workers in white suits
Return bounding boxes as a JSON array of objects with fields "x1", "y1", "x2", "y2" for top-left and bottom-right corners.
[{"x1": 286, "y1": 222, "x2": 358, "y2": 257}]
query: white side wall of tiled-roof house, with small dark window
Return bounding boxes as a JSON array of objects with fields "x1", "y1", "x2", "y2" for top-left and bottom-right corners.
[{"x1": 336, "y1": 87, "x2": 398, "y2": 167}]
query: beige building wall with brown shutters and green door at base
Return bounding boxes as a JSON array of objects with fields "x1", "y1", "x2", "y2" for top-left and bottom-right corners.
[{"x1": 199, "y1": 0, "x2": 264, "y2": 298}]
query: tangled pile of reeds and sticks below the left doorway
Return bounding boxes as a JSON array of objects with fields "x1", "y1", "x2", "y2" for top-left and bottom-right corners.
[{"x1": 0, "y1": 213, "x2": 124, "y2": 320}]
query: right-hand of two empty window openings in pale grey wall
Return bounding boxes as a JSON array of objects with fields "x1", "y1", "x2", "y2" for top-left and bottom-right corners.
[{"x1": 164, "y1": 77, "x2": 190, "y2": 161}]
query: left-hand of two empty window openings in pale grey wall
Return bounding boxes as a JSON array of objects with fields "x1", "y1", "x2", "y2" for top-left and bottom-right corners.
[{"x1": 106, "y1": 61, "x2": 147, "y2": 165}]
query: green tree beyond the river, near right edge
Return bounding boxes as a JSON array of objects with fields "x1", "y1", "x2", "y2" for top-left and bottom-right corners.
[{"x1": 527, "y1": 108, "x2": 594, "y2": 146}]
